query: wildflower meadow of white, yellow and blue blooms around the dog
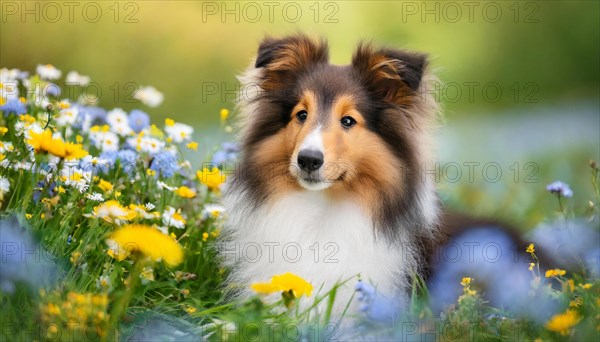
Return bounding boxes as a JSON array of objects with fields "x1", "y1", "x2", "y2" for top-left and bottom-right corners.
[{"x1": 0, "y1": 65, "x2": 600, "y2": 341}]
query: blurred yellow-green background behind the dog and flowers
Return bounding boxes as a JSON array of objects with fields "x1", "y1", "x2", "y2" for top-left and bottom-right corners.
[{"x1": 0, "y1": 1, "x2": 600, "y2": 227}]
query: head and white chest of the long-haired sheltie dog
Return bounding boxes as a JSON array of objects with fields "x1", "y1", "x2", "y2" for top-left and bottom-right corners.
[{"x1": 222, "y1": 35, "x2": 524, "y2": 312}]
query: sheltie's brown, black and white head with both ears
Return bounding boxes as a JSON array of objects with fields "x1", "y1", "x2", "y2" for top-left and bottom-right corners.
[{"x1": 236, "y1": 35, "x2": 436, "y2": 232}]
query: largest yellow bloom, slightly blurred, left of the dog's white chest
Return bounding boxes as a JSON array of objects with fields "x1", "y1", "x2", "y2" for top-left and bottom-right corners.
[{"x1": 107, "y1": 224, "x2": 183, "y2": 266}]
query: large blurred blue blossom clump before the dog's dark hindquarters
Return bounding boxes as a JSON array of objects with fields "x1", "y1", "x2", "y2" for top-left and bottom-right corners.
[{"x1": 428, "y1": 226, "x2": 558, "y2": 322}]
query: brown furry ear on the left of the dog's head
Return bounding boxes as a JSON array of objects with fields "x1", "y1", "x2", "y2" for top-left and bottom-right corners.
[{"x1": 254, "y1": 35, "x2": 329, "y2": 89}]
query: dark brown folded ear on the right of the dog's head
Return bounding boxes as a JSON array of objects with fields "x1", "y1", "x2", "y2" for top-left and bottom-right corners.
[{"x1": 352, "y1": 44, "x2": 427, "y2": 104}]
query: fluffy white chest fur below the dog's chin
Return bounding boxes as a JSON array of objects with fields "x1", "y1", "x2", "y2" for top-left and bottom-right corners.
[{"x1": 221, "y1": 191, "x2": 406, "y2": 305}]
